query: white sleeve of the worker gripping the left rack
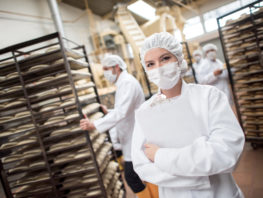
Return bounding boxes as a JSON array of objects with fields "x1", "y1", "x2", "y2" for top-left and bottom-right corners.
[{"x1": 94, "y1": 81, "x2": 136, "y2": 133}]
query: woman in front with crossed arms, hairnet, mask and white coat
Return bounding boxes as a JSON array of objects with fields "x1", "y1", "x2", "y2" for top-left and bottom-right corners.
[{"x1": 132, "y1": 32, "x2": 244, "y2": 198}]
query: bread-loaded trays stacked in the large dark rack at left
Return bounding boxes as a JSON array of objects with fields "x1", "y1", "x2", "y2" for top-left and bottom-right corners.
[{"x1": 0, "y1": 34, "x2": 125, "y2": 198}]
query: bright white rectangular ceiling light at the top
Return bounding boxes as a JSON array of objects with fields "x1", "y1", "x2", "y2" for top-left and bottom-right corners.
[{"x1": 128, "y1": 0, "x2": 155, "y2": 20}]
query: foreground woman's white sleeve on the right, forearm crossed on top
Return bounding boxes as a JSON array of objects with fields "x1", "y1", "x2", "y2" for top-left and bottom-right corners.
[{"x1": 155, "y1": 88, "x2": 244, "y2": 176}]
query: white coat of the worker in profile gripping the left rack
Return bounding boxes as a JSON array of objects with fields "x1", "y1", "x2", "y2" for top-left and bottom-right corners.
[{"x1": 94, "y1": 71, "x2": 144, "y2": 161}]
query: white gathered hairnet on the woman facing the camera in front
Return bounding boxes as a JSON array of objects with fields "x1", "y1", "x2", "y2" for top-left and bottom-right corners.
[{"x1": 140, "y1": 32, "x2": 187, "y2": 76}]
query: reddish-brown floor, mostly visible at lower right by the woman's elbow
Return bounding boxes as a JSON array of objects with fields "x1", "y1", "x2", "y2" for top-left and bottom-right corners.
[{"x1": 0, "y1": 143, "x2": 263, "y2": 198}]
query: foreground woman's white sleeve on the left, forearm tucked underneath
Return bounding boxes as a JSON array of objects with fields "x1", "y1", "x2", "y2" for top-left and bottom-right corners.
[{"x1": 131, "y1": 117, "x2": 210, "y2": 189}]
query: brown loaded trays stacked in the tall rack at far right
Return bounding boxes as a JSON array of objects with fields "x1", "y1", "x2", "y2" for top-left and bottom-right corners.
[{"x1": 222, "y1": 5, "x2": 263, "y2": 138}]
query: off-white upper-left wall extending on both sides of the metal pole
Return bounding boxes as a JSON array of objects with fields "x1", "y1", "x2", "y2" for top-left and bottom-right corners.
[{"x1": 0, "y1": 0, "x2": 116, "y2": 52}]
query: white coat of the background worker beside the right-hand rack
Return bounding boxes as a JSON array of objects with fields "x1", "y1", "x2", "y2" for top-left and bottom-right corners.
[{"x1": 198, "y1": 58, "x2": 233, "y2": 105}]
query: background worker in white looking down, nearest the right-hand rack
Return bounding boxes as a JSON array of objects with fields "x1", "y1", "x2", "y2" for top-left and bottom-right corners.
[{"x1": 199, "y1": 43, "x2": 233, "y2": 105}]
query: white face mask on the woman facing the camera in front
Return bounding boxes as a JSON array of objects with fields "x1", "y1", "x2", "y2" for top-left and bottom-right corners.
[{"x1": 146, "y1": 62, "x2": 181, "y2": 90}]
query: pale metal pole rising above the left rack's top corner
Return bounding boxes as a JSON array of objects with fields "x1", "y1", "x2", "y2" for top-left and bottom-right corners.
[{"x1": 48, "y1": 0, "x2": 65, "y2": 38}]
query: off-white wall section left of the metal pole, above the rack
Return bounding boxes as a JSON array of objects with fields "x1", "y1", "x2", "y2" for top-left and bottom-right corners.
[{"x1": 0, "y1": 0, "x2": 55, "y2": 48}]
